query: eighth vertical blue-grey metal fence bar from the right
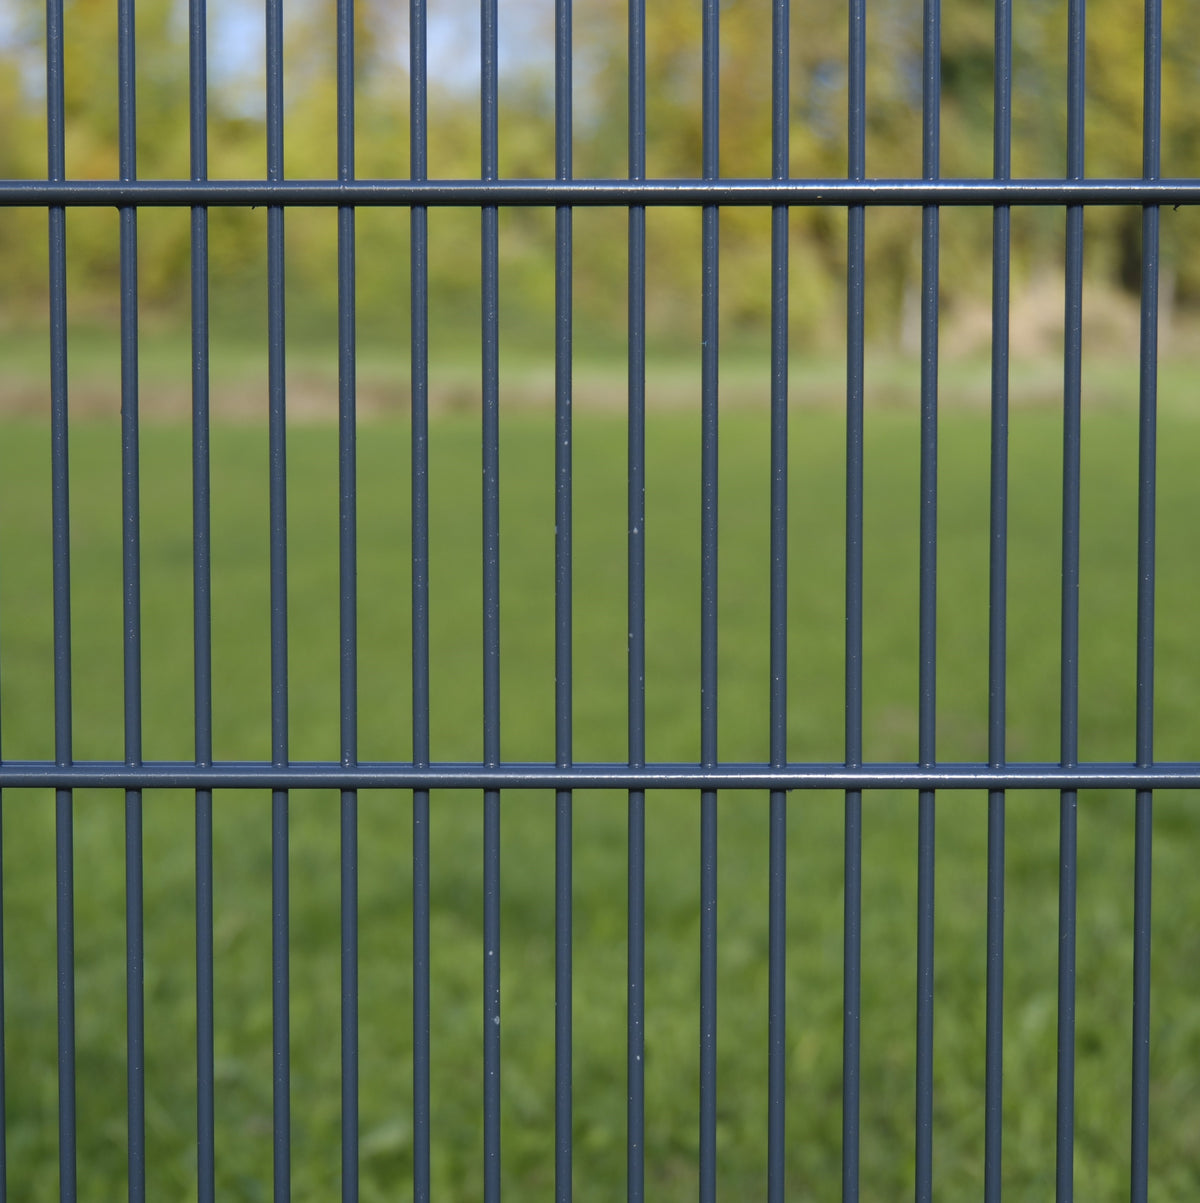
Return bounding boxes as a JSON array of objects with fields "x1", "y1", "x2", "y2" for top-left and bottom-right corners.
[{"x1": 625, "y1": 0, "x2": 646, "y2": 1203}]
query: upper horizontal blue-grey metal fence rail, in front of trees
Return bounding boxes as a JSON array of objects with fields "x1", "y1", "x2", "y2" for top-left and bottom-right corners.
[{"x1": 0, "y1": 178, "x2": 1200, "y2": 207}]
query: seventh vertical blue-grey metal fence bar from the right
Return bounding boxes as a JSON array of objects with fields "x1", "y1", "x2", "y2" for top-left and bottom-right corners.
[{"x1": 700, "y1": 0, "x2": 720, "y2": 1203}]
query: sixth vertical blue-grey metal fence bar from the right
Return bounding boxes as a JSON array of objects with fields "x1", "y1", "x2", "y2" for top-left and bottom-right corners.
[{"x1": 767, "y1": 0, "x2": 791, "y2": 1203}]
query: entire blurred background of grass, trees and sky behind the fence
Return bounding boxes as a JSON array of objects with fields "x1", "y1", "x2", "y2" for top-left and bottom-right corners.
[{"x1": 0, "y1": 0, "x2": 1200, "y2": 1203}]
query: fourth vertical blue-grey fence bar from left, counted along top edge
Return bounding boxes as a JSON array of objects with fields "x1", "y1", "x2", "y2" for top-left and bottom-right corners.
[{"x1": 266, "y1": 0, "x2": 291, "y2": 1203}]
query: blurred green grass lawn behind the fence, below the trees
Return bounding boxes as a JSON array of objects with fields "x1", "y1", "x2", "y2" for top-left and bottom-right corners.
[{"x1": 0, "y1": 403, "x2": 1200, "y2": 1203}]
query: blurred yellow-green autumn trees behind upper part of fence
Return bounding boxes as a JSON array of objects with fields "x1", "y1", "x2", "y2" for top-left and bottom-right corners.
[{"x1": 0, "y1": 0, "x2": 1200, "y2": 342}]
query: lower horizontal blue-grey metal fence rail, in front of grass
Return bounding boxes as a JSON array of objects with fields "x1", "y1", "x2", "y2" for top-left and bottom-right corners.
[{"x1": 0, "y1": 760, "x2": 1200, "y2": 790}]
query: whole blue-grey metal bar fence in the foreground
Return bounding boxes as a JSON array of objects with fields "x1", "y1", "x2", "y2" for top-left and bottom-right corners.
[{"x1": 0, "y1": 0, "x2": 1200, "y2": 1199}]
